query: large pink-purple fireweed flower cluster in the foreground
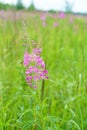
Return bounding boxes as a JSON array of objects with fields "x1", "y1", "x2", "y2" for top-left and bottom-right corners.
[{"x1": 24, "y1": 48, "x2": 48, "y2": 88}]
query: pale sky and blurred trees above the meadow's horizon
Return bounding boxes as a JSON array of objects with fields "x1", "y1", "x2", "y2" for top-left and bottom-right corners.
[{"x1": 0, "y1": 0, "x2": 87, "y2": 13}]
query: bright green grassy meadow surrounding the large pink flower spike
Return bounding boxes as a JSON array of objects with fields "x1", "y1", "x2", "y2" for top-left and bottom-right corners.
[{"x1": 0, "y1": 11, "x2": 87, "y2": 130}]
